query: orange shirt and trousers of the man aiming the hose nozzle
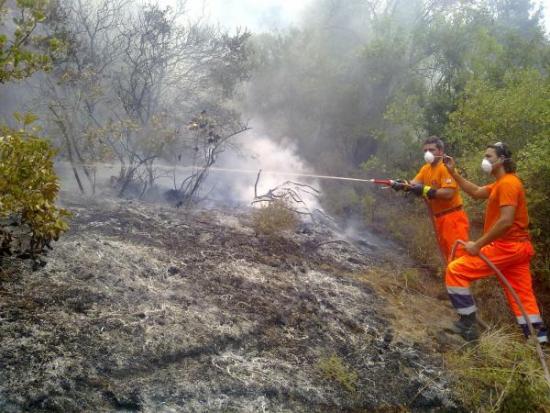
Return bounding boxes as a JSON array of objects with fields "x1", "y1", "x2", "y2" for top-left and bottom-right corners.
[{"x1": 414, "y1": 162, "x2": 469, "y2": 260}]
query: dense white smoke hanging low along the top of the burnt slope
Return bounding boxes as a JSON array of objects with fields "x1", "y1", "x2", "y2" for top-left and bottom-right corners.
[{"x1": 56, "y1": 120, "x2": 321, "y2": 211}]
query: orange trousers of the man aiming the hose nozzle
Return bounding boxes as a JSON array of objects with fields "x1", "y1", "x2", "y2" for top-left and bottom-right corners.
[{"x1": 435, "y1": 210, "x2": 470, "y2": 261}]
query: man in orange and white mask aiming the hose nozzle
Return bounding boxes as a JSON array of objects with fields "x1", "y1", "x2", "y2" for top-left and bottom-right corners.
[{"x1": 392, "y1": 136, "x2": 469, "y2": 264}]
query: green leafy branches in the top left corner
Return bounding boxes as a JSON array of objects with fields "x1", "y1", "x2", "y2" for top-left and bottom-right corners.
[{"x1": 0, "y1": 0, "x2": 56, "y2": 83}]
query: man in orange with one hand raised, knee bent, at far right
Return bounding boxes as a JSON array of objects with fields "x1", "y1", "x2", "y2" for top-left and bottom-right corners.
[{"x1": 445, "y1": 142, "x2": 548, "y2": 343}]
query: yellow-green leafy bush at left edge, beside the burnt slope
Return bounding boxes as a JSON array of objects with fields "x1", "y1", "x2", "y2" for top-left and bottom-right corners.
[{"x1": 0, "y1": 120, "x2": 68, "y2": 253}]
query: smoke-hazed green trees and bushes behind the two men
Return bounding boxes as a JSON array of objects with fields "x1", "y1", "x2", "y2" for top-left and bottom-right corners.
[{"x1": 249, "y1": 0, "x2": 550, "y2": 292}]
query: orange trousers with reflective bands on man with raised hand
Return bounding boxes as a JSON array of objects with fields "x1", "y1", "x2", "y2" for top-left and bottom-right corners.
[{"x1": 445, "y1": 241, "x2": 546, "y2": 341}]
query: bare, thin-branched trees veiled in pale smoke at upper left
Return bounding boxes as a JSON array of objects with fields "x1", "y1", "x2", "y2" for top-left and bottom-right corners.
[{"x1": 38, "y1": 0, "x2": 249, "y2": 196}]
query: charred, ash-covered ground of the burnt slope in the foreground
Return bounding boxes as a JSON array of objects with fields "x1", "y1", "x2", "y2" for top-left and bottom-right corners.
[{"x1": 0, "y1": 195, "x2": 462, "y2": 412}]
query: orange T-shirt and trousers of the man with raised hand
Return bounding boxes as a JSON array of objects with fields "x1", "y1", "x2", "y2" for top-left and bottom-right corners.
[{"x1": 445, "y1": 173, "x2": 548, "y2": 342}]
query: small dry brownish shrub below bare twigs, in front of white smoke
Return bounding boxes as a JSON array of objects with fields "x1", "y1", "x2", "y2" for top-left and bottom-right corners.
[{"x1": 252, "y1": 199, "x2": 298, "y2": 236}]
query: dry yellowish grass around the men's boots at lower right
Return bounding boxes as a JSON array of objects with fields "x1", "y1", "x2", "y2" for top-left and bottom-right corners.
[{"x1": 361, "y1": 260, "x2": 550, "y2": 413}]
